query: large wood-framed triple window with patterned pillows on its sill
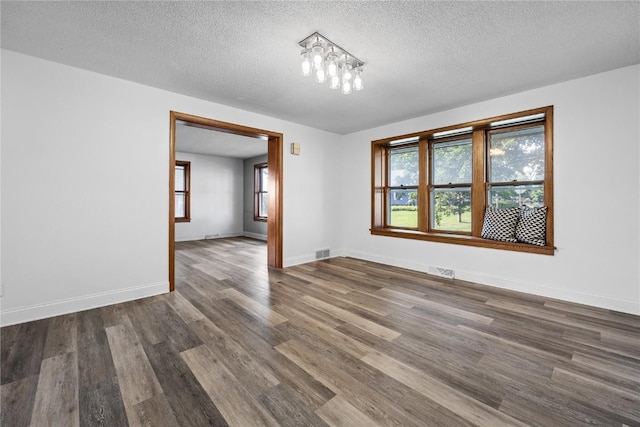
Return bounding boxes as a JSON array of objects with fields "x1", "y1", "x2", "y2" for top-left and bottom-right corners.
[{"x1": 371, "y1": 107, "x2": 554, "y2": 254}]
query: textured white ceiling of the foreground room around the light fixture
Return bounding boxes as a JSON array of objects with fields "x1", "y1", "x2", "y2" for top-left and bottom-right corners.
[{"x1": 1, "y1": 1, "x2": 640, "y2": 133}]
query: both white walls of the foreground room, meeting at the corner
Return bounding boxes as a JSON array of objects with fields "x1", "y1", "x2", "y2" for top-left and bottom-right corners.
[{"x1": 0, "y1": 50, "x2": 640, "y2": 325}]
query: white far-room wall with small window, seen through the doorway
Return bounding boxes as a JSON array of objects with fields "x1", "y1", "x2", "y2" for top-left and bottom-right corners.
[{"x1": 176, "y1": 152, "x2": 244, "y2": 242}]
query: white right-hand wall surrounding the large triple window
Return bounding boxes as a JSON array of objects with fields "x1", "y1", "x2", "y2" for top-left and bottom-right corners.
[{"x1": 341, "y1": 65, "x2": 640, "y2": 314}]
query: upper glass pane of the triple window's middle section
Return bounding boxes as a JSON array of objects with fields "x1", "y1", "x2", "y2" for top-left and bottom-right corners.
[{"x1": 432, "y1": 138, "x2": 473, "y2": 184}]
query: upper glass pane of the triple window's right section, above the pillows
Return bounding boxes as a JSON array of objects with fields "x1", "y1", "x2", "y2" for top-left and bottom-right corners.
[{"x1": 489, "y1": 126, "x2": 544, "y2": 182}]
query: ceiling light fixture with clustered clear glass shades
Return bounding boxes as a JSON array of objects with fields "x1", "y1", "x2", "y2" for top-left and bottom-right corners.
[{"x1": 298, "y1": 32, "x2": 364, "y2": 95}]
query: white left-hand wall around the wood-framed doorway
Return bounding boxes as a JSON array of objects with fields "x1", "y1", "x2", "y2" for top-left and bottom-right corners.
[{"x1": 0, "y1": 50, "x2": 342, "y2": 325}]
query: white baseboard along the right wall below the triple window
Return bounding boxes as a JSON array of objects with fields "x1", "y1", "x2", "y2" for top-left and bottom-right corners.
[{"x1": 345, "y1": 251, "x2": 640, "y2": 315}]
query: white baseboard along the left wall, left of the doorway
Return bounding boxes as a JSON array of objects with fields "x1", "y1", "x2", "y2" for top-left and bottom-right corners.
[{"x1": 0, "y1": 282, "x2": 169, "y2": 326}]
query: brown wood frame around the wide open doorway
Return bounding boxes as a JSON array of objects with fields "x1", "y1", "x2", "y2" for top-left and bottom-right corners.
[{"x1": 169, "y1": 111, "x2": 284, "y2": 292}]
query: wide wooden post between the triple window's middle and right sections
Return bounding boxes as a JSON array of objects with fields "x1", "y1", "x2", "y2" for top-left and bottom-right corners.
[{"x1": 471, "y1": 130, "x2": 487, "y2": 237}]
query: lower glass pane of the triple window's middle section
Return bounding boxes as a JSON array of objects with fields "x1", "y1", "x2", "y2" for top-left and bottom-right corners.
[{"x1": 431, "y1": 187, "x2": 471, "y2": 232}]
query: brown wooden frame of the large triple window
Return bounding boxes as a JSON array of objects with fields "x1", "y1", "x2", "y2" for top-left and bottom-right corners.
[{"x1": 370, "y1": 106, "x2": 555, "y2": 255}]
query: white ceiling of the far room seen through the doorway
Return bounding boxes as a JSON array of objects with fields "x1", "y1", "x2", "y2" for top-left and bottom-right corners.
[{"x1": 176, "y1": 121, "x2": 268, "y2": 159}]
